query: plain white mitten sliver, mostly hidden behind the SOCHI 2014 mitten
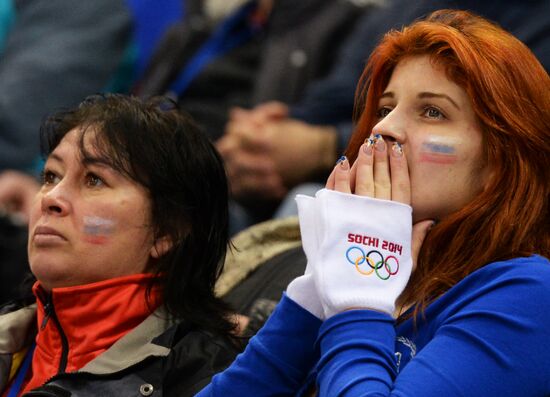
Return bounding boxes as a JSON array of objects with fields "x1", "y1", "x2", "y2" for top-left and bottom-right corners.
[{"x1": 286, "y1": 194, "x2": 324, "y2": 319}]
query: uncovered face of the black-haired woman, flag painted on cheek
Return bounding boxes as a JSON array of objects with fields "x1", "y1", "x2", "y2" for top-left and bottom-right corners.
[{"x1": 28, "y1": 129, "x2": 158, "y2": 289}]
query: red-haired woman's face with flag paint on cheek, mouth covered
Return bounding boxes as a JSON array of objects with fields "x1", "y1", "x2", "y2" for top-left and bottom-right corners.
[{"x1": 373, "y1": 56, "x2": 489, "y2": 222}]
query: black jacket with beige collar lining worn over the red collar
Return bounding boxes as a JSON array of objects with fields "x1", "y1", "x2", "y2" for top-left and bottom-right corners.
[{"x1": 0, "y1": 305, "x2": 239, "y2": 397}]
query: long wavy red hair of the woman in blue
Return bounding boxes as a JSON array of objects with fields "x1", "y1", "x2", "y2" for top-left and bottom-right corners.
[{"x1": 346, "y1": 10, "x2": 550, "y2": 315}]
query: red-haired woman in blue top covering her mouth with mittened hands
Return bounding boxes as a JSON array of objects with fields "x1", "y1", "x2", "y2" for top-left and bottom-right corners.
[{"x1": 199, "y1": 10, "x2": 550, "y2": 397}]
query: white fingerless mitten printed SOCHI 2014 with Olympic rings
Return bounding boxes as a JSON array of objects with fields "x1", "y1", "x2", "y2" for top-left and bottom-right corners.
[{"x1": 313, "y1": 189, "x2": 412, "y2": 318}]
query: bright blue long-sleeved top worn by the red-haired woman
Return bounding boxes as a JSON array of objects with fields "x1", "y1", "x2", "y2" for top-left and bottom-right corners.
[{"x1": 198, "y1": 255, "x2": 550, "y2": 397}]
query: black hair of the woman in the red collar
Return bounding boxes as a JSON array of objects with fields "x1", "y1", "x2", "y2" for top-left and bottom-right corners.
[{"x1": 40, "y1": 94, "x2": 234, "y2": 333}]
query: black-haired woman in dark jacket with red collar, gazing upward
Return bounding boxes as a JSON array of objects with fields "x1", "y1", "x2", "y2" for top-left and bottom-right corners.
[{"x1": 0, "y1": 95, "x2": 242, "y2": 397}]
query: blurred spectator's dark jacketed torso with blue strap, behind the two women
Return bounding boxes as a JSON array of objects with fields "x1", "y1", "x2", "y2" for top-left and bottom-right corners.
[{"x1": 136, "y1": 0, "x2": 374, "y2": 139}]
